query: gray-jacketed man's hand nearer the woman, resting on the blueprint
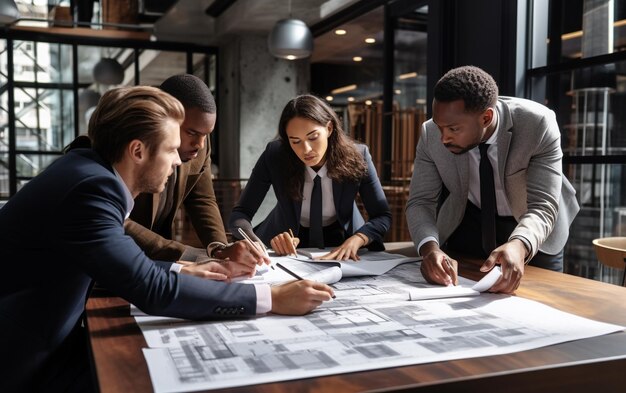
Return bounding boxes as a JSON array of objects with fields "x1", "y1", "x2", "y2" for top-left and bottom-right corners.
[{"x1": 420, "y1": 242, "x2": 459, "y2": 285}]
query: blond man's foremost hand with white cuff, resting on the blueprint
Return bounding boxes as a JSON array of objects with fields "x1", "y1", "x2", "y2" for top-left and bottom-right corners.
[{"x1": 271, "y1": 280, "x2": 334, "y2": 315}]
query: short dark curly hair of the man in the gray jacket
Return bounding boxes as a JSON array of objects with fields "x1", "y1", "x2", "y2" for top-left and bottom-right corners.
[{"x1": 433, "y1": 66, "x2": 498, "y2": 112}]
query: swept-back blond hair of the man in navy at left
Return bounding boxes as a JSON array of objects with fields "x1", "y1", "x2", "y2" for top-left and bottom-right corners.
[{"x1": 87, "y1": 86, "x2": 185, "y2": 164}]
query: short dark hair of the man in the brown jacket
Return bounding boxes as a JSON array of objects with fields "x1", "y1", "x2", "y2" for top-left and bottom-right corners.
[{"x1": 160, "y1": 74, "x2": 217, "y2": 114}]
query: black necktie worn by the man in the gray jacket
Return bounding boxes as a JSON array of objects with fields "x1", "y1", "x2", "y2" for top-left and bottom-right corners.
[{"x1": 478, "y1": 143, "x2": 496, "y2": 254}]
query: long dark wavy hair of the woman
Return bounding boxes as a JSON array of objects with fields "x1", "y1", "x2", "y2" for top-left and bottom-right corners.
[{"x1": 278, "y1": 94, "x2": 367, "y2": 200}]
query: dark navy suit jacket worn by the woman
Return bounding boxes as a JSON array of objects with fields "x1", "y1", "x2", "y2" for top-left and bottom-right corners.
[{"x1": 229, "y1": 140, "x2": 391, "y2": 250}]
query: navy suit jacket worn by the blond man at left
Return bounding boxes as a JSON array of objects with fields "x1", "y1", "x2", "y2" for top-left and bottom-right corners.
[{"x1": 0, "y1": 149, "x2": 256, "y2": 391}]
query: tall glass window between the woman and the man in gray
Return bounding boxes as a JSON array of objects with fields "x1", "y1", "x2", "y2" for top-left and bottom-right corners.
[{"x1": 311, "y1": 1, "x2": 428, "y2": 241}]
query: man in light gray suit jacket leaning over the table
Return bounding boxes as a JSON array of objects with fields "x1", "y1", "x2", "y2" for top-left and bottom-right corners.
[{"x1": 406, "y1": 66, "x2": 579, "y2": 293}]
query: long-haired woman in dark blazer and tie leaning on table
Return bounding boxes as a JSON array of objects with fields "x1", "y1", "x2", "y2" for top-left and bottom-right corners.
[{"x1": 229, "y1": 95, "x2": 391, "y2": 259}]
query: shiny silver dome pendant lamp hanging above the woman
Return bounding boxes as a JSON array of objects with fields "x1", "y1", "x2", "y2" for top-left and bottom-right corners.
[{"x1": 267, "y1": 0, "x2": 313, "y2": 60}]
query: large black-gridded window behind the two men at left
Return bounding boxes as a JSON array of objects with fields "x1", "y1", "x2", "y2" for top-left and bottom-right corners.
[{"x1": 0, "y1": 30, "x2": 218, "y2": 199}]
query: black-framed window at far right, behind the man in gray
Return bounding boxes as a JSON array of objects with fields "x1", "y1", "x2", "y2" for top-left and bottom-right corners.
[{"x1": 528, "y1": 0, "x2": 626, "y2": 282}]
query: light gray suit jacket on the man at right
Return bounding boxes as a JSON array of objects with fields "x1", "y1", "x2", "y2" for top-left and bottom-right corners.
[{"x1": 406, "y1": 97, "x2": 580, "y2": 256}]
